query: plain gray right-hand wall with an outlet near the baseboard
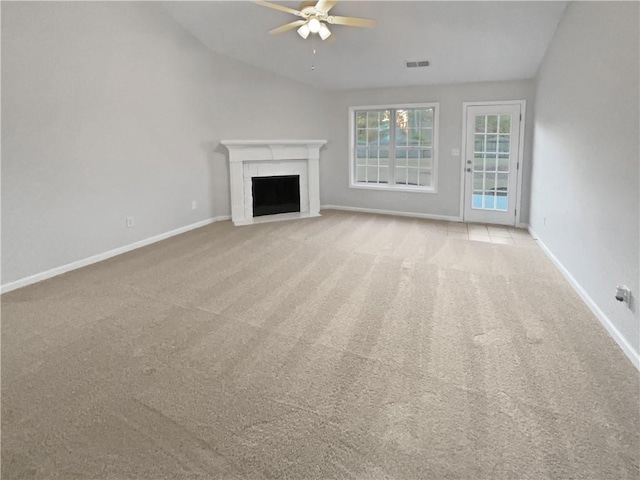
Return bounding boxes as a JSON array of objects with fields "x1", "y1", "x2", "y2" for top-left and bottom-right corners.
[{"x1": 530, "y1": 2, "x2": 640, "y2": 353}]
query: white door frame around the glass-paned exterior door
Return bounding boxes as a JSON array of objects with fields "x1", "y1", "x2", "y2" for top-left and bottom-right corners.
[{"x1": 460, "y1": 100, "x2": 527, "y2": 227}]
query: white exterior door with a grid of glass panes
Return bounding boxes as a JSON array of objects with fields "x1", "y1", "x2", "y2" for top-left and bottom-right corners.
[{"x1": 464, "y1": 102, "x2": 523, "y2": 225}]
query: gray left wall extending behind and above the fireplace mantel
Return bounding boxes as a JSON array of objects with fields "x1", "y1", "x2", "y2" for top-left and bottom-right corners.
[{"x1": 2, "y1": 2, "x2": 326, "y2": 284}]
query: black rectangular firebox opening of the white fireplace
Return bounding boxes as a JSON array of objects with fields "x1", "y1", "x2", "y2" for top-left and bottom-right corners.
[{"x1": 251, "y1": 175, "x2": 300, "y2": 217}]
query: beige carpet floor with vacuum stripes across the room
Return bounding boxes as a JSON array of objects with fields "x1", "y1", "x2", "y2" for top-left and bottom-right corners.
[{"x1": 2, "y1": 211, "x2": 640, "y2": 480}]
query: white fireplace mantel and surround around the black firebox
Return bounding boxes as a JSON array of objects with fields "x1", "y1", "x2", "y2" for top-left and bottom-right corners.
[{"x1": 220, "y1": 140, "x2": 327, "y2": 225}]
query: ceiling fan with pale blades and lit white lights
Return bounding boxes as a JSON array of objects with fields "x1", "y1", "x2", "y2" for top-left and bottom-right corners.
[{"x1": 255, "y1": 0, "x2": 377, "y2": 40}]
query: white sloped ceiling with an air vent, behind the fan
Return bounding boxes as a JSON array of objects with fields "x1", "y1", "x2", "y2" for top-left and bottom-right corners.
[{"x1": 163, "y1": 1, "x2": 566, "y2": 90}]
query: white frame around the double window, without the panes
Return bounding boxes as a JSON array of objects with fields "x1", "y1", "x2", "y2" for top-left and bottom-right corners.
[{"x1": 349, "y1": 102, "x2": 440, "y2": 193}]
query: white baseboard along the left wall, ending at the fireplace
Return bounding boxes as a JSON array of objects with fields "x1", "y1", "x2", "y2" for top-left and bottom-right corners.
[{"x1": 0, "y1": 215, "x2": 231, "y2": 293}]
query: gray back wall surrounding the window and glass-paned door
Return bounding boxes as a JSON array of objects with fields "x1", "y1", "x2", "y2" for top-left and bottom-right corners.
[{"x1": 321, "y1": 80, "x2": 535, "y2": 223}]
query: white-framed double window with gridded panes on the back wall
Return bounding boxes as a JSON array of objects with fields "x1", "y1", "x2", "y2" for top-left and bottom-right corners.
[{"x1": 349, "y1": 103, "x2": 438, "y2": 192}]
